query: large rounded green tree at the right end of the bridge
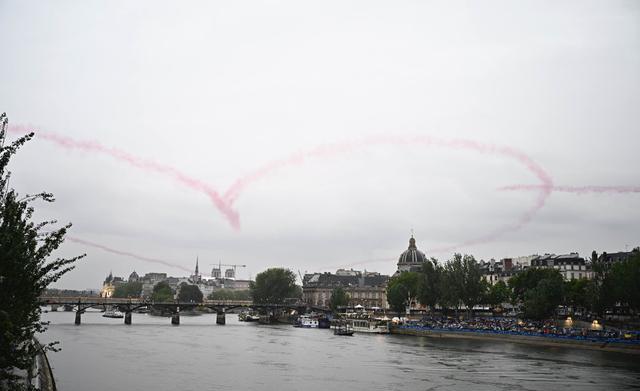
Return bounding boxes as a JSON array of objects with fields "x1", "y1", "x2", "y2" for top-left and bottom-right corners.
[{"x1": 249, "y1": 268, "x2": 301, "y2": 304}]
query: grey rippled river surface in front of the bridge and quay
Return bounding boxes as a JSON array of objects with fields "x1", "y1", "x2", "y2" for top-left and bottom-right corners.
[{"x1": 41, "y1": 312, "x2": 640, "y2": 391}]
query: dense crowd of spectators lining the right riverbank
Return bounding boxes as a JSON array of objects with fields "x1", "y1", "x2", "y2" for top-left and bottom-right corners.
[{"x1": 401, "y1": 316, "x2": 640, "y2": 342}]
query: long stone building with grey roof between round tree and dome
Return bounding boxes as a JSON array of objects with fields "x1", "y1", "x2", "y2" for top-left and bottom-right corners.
[{"x1": 302, "y1": 269, "x2": 389, "y2": 308}]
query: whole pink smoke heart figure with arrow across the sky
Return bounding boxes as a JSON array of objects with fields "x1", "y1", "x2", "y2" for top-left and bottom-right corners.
[{"x1": 9, "y1": 126, "x2": 640, "y2": 266}]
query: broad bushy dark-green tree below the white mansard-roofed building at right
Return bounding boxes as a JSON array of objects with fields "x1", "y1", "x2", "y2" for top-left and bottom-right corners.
[{"x1": 509, "y1": 268, "x2": 564, "y2": 319}]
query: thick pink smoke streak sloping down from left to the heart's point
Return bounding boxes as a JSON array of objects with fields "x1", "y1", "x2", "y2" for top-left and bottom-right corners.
[{"x1": 9, "y1": 126, "x2": 240, "y2": 230}]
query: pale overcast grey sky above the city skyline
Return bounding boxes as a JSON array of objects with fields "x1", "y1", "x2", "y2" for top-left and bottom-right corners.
[{"x1": 0, "y1": 0, "x2": 640, "y2": 289}]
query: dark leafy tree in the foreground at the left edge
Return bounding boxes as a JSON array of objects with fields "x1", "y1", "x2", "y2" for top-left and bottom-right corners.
[{"x1": 0, "y1": 113, "x2": 84, "y2": 389}]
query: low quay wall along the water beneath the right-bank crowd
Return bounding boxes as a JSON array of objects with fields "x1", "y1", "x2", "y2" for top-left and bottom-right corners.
[{"x1": 390, "y1": 326, "x2": 640, "y2": 354}]
